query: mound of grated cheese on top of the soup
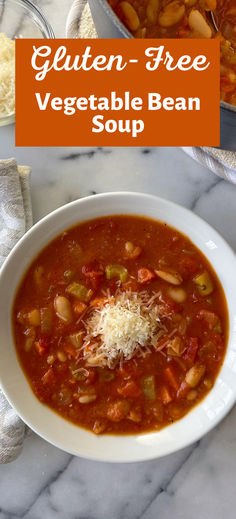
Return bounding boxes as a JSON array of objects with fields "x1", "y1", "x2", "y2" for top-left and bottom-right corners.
[{"x1": 83, "y1": 291, "x2": 165, "y2": 368}]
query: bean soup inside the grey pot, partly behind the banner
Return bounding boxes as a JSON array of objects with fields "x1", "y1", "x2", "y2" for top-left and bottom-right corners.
[{"x1": 108, "y1": 0, "x2": 236, "y2": 106}]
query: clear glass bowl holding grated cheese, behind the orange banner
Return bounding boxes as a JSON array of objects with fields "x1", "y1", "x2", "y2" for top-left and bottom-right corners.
[{"x1": 0, "y1": 0, "x2": 55, "y2": 126}]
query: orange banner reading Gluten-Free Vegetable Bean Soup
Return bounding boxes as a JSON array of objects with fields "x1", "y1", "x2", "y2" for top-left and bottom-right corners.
[{"x1": 16, "y1": 39, "x2": 220, "y2": 146}]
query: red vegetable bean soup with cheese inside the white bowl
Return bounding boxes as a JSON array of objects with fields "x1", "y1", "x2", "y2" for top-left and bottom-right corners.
[{"x1": 13, "y1": 215, "x2": 228, "y2": 434}]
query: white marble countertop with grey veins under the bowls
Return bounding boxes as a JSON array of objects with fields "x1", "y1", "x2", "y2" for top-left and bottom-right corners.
[{"x1": 0, "y1": 0, "x2": 236, "y2": 519}]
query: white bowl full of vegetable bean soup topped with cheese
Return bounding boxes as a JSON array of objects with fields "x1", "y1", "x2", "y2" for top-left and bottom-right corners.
[{"x1": 0, "y1": 193, "x2": 236, "y2": 462}]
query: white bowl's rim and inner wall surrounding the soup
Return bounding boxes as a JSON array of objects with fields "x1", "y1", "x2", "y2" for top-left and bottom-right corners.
[{"x1": 0, "y1": 193, "x2": 236, "y2": 462}]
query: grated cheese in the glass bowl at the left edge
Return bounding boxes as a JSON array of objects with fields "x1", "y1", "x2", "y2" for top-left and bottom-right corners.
[{"x1": 0, "y1": 33, "x2": 15, "y2": 117}]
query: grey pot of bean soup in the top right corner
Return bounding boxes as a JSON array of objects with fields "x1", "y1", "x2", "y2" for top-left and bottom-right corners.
[{"x1": 89, "y1": 0, "x2": 236, "y2": 151}]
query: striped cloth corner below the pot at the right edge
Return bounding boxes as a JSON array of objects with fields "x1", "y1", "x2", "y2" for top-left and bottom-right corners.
[{"x1": 182, "y1": 148, "x2": 236, "y2": 184}]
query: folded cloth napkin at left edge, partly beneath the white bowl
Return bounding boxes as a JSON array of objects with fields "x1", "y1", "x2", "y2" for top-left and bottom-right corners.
[{"x1": 0, "y1": 159, "x2": 33, "y2": 463}]
